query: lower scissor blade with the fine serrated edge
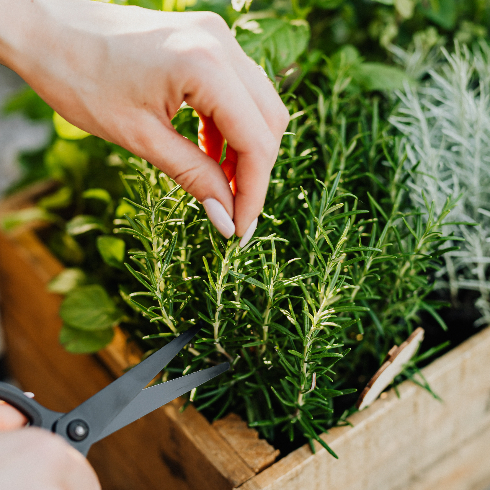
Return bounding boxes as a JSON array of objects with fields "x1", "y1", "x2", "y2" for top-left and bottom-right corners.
[{"x1": 97, "y1": 362, "x2": 230, "y2": 441}]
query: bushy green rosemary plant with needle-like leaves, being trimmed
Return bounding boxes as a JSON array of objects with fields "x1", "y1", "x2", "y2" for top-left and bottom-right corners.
[{"x1": 100, "y1": 55, "x2": 455, "y2": 454}]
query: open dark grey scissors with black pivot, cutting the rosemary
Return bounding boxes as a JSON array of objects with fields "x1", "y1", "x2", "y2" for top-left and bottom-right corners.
[{"x1": 0, "y1": 324, "x2": 230, "y2": 456}]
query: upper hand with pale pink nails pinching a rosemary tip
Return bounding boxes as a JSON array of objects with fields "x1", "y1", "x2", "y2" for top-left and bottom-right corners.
[{"x1": 0, "y1": 0, "x2": 289, "y2": 241}]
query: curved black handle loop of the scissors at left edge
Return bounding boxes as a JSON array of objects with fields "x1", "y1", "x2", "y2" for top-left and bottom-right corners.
[{"x1": 0, "y1": 382, "x2": 63, "y2": 430}]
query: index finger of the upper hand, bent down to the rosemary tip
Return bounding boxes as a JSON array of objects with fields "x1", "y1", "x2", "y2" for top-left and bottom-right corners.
[{"x1": 187, "y1": 66, "x2": 279, "y2": 236}]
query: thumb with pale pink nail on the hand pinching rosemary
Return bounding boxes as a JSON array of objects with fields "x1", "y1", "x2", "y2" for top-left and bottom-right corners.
[{"x1": 132, "y1": 113, "x2": 235, "y2": 238}]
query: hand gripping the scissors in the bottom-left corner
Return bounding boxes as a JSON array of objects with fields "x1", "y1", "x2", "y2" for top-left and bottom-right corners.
[{"x1": 0, "y1": 402, "x2": 100, "y2": 490}]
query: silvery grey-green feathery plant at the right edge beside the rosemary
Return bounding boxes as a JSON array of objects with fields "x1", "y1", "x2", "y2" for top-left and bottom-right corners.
[{"x1": 390, "y1": 43, "x2": 490, "y2": 325}]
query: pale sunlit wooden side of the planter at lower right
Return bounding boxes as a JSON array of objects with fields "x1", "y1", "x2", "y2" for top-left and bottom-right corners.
[{"x1": 240, "y1": 326, "x2": 490, "y2": 490}]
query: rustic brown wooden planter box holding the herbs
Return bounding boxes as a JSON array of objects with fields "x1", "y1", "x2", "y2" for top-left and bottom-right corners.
[{"x1": 0, "y1": 185, "x2": 490, "y2": 490}]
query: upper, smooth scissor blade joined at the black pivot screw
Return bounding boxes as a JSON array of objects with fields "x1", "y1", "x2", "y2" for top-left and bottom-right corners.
[{"x1": 56, "y1": 324, "x2": 201, "y2": 444}]
